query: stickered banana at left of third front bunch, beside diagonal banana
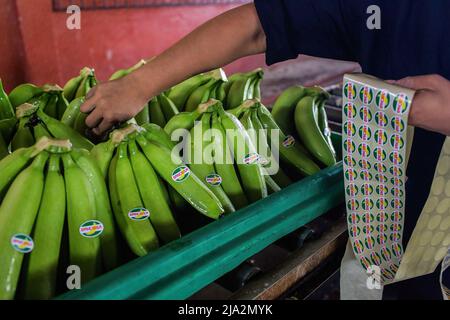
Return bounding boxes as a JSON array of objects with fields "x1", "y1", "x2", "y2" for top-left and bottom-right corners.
[{"x1": 186, "y1": 113, "x2": 236, "y2": 213}]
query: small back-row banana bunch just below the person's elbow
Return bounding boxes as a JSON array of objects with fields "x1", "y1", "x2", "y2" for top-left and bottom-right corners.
[{"x1": 224, "y1": 68, "x2": 264, "y2": 109}]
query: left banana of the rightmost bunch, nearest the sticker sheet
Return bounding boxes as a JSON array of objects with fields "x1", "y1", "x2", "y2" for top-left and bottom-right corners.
[{"x1": 272, "y1": 86, "x2": 306, "y2": 135}]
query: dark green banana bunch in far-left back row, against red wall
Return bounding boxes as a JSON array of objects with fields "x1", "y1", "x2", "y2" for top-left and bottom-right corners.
[{"x1": 9, "y1": 83, "x2": 69, "y2": 119}]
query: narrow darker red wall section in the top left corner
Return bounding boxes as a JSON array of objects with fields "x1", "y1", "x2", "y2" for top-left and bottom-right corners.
[{"x1": 0, "y1": 0, "x2": 25, "y2": 90}]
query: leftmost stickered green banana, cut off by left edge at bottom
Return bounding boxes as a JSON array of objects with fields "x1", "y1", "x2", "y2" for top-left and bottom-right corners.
[{"x1": 0, "y1": 152, "x2": 48, "y2": 300}]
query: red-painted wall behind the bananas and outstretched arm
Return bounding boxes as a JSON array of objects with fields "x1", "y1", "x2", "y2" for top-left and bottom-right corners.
[{"x1": 0, "y1": 0, "x2": 264, "y2": 90}]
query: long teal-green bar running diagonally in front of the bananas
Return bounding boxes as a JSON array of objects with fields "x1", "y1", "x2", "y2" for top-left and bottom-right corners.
[{"x1": 58, "y1": 161, "x2": 344, "y2": 299}]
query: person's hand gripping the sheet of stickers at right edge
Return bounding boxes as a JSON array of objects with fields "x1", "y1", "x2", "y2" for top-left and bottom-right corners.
[{"x1": 393, "y1": 75, "x2": 450, "y2": 136}]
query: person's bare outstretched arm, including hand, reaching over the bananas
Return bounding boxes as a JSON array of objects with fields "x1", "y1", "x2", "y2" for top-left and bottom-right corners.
[{"x1": 81, "y1": 4, "x2": 266, "y2": 134}]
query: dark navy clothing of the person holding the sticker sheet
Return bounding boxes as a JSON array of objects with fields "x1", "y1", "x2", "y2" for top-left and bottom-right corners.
[{"x1": 255, "y1": 0, "x2": 450, "y2": 299}]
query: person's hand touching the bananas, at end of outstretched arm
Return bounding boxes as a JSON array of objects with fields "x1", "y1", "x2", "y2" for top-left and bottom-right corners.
[{"x1": 80, "y1": 76, "x2": 148, "y2": 135}]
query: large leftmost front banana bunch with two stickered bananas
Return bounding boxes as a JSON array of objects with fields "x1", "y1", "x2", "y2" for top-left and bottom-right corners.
[{"x1": 0, "y1": 137, "x2": 119, "y2": 299}]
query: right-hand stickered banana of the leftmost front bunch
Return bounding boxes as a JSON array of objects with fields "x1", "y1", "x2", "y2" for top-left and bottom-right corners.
[{"x1": 61, "y1": 153, "x2": 101, "y2": 284}]
